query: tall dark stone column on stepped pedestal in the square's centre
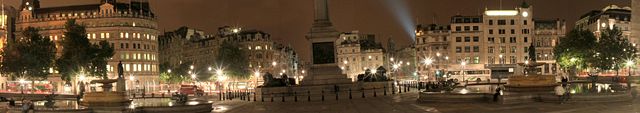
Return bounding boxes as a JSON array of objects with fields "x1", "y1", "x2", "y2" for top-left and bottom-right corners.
[{"x1": 302, "y1": 0, "x2": 351, "y2": 85}]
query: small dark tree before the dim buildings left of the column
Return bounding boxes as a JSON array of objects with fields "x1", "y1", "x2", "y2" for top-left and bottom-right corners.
[{"x1": 216, "y1": 41, "x2": 250, "y2": 79}]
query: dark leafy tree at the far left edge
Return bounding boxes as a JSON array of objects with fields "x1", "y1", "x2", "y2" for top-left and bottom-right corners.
[{"x1": 0, "y1": 27, "x2": 56, "y2": 80}]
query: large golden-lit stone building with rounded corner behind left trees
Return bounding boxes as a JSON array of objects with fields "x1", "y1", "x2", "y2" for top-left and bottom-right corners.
[{"x1": 15, "y1": 0, "x2": 160, "y2": 93}]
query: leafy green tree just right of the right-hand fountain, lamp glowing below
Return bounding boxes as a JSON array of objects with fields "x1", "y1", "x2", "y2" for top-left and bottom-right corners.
[{"x1": 552, "y1": 29, "x2": 597, "y2": 76}]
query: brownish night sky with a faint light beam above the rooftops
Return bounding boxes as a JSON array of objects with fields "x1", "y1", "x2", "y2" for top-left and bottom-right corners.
[{"x1": 5, "y1": 0, "x2": 631, "y2": 60}]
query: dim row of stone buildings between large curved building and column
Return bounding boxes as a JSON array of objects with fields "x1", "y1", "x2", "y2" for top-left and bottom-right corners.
[{"x1": 159, "y1": 26, "x2": 303, "y2": 86}]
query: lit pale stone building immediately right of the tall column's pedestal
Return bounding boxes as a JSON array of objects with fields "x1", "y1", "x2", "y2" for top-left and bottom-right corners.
[{"x1": 335, "y1": 31, "x2": 387, "y2": 81}]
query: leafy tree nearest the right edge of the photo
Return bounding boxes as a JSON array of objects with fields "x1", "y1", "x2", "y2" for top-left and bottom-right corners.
[{"x1": 593, "y1": 27, "x2": 637, "y2": 70}]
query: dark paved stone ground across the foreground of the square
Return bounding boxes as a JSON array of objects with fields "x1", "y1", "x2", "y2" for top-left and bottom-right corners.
[{"x1": 206, "y1": 92, "x2": 640, "y2": 113}]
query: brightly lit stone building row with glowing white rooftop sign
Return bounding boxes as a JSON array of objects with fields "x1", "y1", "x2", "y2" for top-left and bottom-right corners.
[{"x1": 416, "y1": 3, "x2": 566, "y2": 81}]
